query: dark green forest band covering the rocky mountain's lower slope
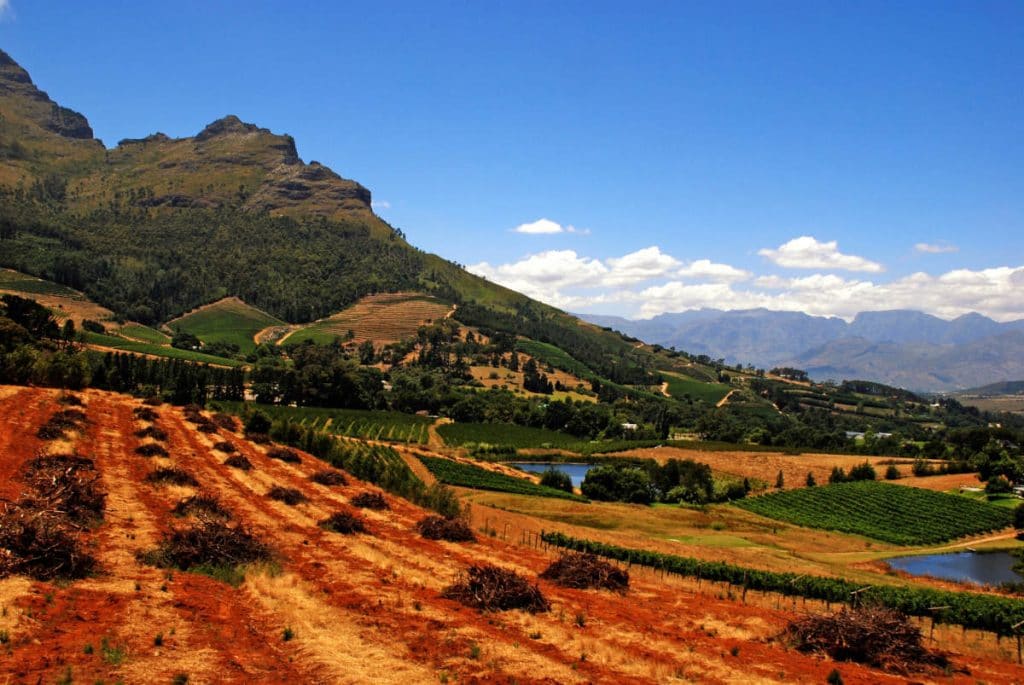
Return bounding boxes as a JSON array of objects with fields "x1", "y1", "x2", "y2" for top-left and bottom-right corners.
[{"x1": 0, "y1": 194, "x2": 423, "y2": 325}]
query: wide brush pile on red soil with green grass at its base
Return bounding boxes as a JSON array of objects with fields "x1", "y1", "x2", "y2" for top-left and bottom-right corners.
[{"x1": 139, "y1": 518, "x2": 271, "y2": 570}]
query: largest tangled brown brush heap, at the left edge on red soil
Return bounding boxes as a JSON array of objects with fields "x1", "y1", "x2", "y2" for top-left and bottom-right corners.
[{"x1": 0, "y1": 455, "x2": 106, "y2": 581}]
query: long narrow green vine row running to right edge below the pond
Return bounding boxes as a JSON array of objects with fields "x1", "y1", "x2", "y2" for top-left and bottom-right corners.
[{"x1": 541, "y1": 532, "x2": 1024, "y2": 636}]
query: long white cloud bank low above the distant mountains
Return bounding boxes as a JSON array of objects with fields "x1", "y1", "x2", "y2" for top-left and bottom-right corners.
[{"x1": 469, "y1": 246, "x2": 1024, "y2": 320}]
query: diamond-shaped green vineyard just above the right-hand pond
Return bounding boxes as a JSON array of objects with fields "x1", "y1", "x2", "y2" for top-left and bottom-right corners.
[{"x1": 734, "y1": 480, "x2": 1013, "y2": 545}]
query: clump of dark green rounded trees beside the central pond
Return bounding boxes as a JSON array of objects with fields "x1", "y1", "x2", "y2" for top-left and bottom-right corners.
[{"x1": 580, "y1": 459, "x2": 751, "y2": 505}]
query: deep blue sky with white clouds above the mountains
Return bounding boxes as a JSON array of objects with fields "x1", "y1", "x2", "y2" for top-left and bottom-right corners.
[{"x1": 0, "y1": 0, "x2": 1024, "y2": 319}]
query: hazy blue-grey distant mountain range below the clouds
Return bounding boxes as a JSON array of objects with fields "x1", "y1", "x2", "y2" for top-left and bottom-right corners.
[{"x1": 582, "y1": 309, "x2": 1024, "y2": 392}]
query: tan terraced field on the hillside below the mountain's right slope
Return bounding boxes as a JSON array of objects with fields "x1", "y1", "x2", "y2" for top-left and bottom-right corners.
[{"x1": 280, "y1": 293, "x2": 452, "y2": 346}]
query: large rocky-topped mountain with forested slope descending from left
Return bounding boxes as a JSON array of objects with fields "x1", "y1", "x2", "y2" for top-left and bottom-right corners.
[{"x1": 0, "y1": 52, "x2": 654, "y2": 385}]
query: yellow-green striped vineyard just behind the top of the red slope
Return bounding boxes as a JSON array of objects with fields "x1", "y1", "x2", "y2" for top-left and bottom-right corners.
[{"x1": 222, "y1": 402, "x2": 433, "y2": 444}]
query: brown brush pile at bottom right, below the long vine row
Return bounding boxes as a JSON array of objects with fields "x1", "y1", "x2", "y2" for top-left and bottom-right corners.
[{"x1": 783, "y1": 606, "x2": 947, "y2": 674}]
